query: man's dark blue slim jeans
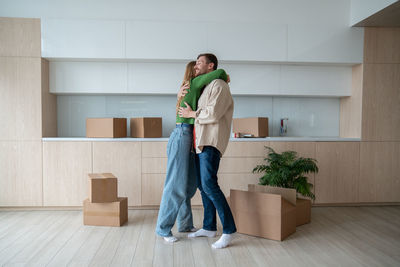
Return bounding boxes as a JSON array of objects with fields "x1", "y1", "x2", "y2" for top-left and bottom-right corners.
[{"x1": 196, "y1": 146, "x2": 236, "y2": 234}]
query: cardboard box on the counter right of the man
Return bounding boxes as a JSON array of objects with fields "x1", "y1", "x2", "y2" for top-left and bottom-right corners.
[{"x1": 232, "y1": 117, "x2": 268, "y2": 137}]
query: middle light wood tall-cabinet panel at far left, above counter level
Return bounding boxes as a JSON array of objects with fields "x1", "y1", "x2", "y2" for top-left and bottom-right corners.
[{"x1": 0, "y1": 57, "x2": 42, "y2": 141}]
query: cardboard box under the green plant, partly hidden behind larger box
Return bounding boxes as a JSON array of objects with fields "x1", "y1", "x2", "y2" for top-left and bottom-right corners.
[{"x1": 248, "y1": 184, "x2": 311, "y2": 226}]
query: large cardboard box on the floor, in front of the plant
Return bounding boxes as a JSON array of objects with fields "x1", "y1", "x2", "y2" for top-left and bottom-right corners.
[{"x1": 230, "y1": 189, "x2": 296, "y2": 241}]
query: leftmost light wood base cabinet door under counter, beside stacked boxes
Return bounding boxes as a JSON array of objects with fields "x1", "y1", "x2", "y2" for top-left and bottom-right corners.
[{"x1": 43, "y1": 142, "x2": 92, "y2": 206}]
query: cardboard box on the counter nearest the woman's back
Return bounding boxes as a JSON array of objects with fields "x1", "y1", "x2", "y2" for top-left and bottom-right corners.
[{"x1": 131, "y1": 117, "x2": 162, "y2": 138}]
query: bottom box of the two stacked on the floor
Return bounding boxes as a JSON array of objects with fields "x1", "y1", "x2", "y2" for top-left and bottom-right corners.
[{"x1": 83, "y1": 197, "x2": 128, "y2": 226}]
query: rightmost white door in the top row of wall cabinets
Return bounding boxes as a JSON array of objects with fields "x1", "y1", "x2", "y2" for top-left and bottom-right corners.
[{"x1": 287, "y1": 24, "x2": 364, "y2": 64}]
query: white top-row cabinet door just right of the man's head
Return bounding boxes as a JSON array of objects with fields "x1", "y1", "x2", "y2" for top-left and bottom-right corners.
[{"x1": 207, "y1": 23, "x2": 287, "y2": 61}]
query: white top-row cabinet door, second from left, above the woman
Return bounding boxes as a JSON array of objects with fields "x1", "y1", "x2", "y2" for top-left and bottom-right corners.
[{"x1": 126, "y1": 21, "x2": 207, "y2": 59}]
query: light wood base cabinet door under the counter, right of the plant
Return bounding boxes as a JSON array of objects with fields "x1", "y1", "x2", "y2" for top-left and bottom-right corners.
[{"x1": 315, "y1": 142, "x2": 360, "y2": 204}]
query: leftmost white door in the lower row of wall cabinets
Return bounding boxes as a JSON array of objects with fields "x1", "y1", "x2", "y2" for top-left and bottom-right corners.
[{"x1": 50, "y1": 61, "x2": 128, "y2": 94}]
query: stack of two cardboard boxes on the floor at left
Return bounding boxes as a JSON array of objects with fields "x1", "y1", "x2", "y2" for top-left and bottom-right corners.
[{"x1": 83, "y1": 173, "x2": 128, "y2": 226}]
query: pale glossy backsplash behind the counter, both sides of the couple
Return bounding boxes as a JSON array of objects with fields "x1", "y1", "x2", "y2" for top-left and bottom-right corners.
[{"x1": 57, "y1": 95, "x2": 340, "y2": 137}]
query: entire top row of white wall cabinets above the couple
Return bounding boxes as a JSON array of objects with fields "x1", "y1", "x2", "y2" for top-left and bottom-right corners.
[{"x1": 42, "y1": 19, "x2": 364, "y2": 64}]
